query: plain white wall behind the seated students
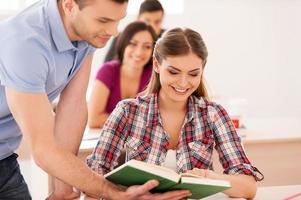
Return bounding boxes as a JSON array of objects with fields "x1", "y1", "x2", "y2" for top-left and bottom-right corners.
[{"x1": 94, "y1": 0, "x2": 301, "y2": 118}]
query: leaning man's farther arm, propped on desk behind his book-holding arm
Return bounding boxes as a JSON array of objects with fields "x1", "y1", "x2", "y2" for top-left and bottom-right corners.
[{"x1": 53, "y1": 55, "x2": 93, "y2": 199}]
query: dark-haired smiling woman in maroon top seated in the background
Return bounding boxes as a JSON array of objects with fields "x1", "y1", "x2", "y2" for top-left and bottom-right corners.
[{"x1": 88, "y1": 22, "x2": 156, "y2": 128}]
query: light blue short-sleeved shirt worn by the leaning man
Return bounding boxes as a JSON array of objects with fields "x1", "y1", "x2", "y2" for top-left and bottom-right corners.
[{"x1": 0, "y1": 0, "x2": 95, "y2": 160}]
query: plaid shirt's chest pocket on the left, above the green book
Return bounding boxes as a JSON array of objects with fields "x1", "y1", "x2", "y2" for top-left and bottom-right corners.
[{"x1": 126, "y1": 138, "x2": 151, "y2": 161}]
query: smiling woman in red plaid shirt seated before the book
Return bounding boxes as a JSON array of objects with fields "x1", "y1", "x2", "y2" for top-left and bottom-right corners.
[{"x1": 87, "y1": 28, "x2": 263, "y2": 198}]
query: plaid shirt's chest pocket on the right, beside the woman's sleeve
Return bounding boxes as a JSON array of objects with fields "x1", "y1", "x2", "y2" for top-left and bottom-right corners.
[{"x1": 188, "y1": 141, "x2": 212, "y2": 168}]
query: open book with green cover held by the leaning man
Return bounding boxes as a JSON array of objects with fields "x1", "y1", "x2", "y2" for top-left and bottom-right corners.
[{"x1": 105, "y1": 160, "x2": 231, "y2": 199}]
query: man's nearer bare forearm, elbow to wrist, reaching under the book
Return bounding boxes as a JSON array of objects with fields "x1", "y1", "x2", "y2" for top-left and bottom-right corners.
[{"x1": 37, "y1": 142, "x2": 119, "y2": 198}]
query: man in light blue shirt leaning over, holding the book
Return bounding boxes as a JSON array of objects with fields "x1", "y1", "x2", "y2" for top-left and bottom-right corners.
[{"x1": 0, "y1": 0, "x2": 189, "y2": 199}]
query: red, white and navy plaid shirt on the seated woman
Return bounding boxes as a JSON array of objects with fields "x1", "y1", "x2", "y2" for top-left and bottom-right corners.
[{"x1": 87, "y1": 94, "x2": 263, "y2": 180}]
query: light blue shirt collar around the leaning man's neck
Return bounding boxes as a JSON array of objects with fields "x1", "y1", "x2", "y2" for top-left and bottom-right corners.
[{"x1": 46, "y1": 0, "x2": 88, "y2": 52}]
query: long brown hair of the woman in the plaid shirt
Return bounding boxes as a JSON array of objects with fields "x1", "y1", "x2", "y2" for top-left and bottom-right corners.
[{"x1": 143, "y1": 28, "x2": 208, "y2": 99}]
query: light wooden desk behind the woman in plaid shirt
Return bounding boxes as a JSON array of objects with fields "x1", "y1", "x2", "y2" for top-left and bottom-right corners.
[{"x1": 79, "y1": 118, "x2": 301, "y2": 186}]
